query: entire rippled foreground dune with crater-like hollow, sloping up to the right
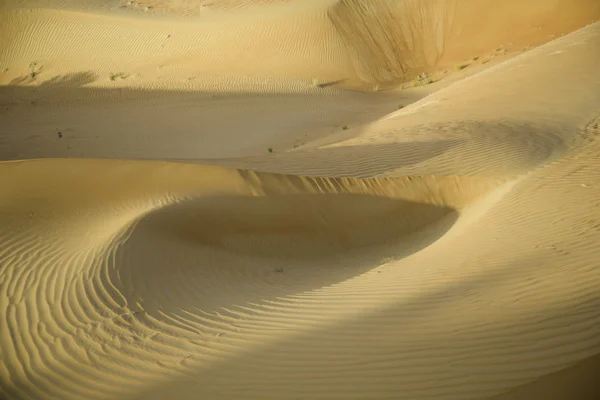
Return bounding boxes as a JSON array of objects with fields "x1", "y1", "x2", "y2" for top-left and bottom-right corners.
[{"x1": 0, "y1": 0, "x2": 600, "y2": 400}]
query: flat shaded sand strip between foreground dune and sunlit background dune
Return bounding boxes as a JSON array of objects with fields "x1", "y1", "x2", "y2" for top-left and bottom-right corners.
[{"x1": 0, "y1": 72, "x2": 426, "y2": 160}]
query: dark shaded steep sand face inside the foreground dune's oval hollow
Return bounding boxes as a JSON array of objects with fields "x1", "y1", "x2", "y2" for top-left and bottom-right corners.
[{"x1": 136, "y1": 194, "x2": 456, "y2": 259}]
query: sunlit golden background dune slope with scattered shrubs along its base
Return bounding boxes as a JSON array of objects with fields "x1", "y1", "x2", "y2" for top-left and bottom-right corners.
[{"x1": 0, "y1": 0, "x2": 600, "y2": 89}]
